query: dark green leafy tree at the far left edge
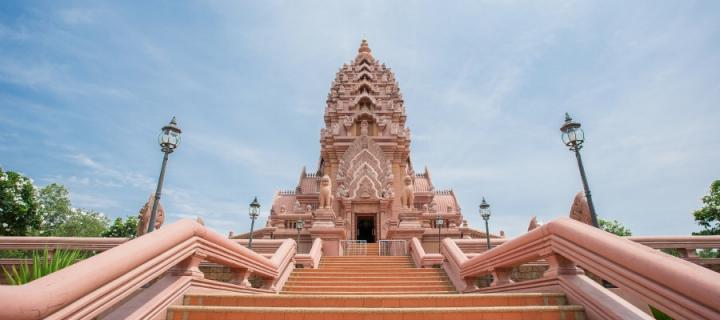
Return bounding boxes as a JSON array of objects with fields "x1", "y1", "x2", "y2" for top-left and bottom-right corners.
[{"x1": 0, "y1": 168, "x2": 41, "y2": 236}]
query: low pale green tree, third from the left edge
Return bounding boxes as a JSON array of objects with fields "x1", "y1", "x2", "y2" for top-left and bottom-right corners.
[{"x1": 52, "y1": 208, "x2": 110, "y2": 237}]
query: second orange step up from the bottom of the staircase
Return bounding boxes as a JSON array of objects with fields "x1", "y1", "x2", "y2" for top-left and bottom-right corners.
[{"x1": 183, "y1": 293, "x2": 567, "y2": 308}]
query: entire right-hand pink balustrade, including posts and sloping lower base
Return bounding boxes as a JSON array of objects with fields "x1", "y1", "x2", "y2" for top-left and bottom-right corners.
[{"x1": 441, "y1": 218, "x2": 720, "y2": 319}]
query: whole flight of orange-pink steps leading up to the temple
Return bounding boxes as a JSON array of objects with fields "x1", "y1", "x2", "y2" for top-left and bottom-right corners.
[{"x1": 167, "y1": 252, "x2": 585, "y2": 320}]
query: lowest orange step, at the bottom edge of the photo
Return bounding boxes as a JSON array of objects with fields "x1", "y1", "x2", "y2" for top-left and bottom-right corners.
[{"x1": 167, "y1": 306, "x2": 585, "y2": 320}]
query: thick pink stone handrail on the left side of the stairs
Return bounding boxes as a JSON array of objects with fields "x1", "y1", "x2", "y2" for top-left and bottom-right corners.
[{"x1": 0, "y1": 219, "x2": 295, "y2": 319}]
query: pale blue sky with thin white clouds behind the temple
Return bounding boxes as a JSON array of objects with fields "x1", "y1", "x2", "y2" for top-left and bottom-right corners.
[{"x1": 0, "y1": 1, "x2": 720, "y2": 236}]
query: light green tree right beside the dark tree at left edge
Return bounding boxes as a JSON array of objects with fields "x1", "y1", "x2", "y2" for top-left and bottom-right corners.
[{"x1": 38, "y1": 183, "x2": 72, "y2": 236}]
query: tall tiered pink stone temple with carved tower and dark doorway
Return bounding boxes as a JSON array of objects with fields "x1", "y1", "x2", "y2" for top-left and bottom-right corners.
[{"x1": 245, "y1": 40, "x2": 492, "y2": 255}]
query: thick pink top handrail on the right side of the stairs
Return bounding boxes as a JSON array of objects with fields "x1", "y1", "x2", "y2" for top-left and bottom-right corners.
[{"x1": 443, "y1": 218, "x2": 720, "y2": 319}]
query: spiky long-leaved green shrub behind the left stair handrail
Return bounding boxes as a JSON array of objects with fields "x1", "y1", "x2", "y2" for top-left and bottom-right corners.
[{"x1": 2, "y1": 248, "x2": 87, "y2": 285}]
